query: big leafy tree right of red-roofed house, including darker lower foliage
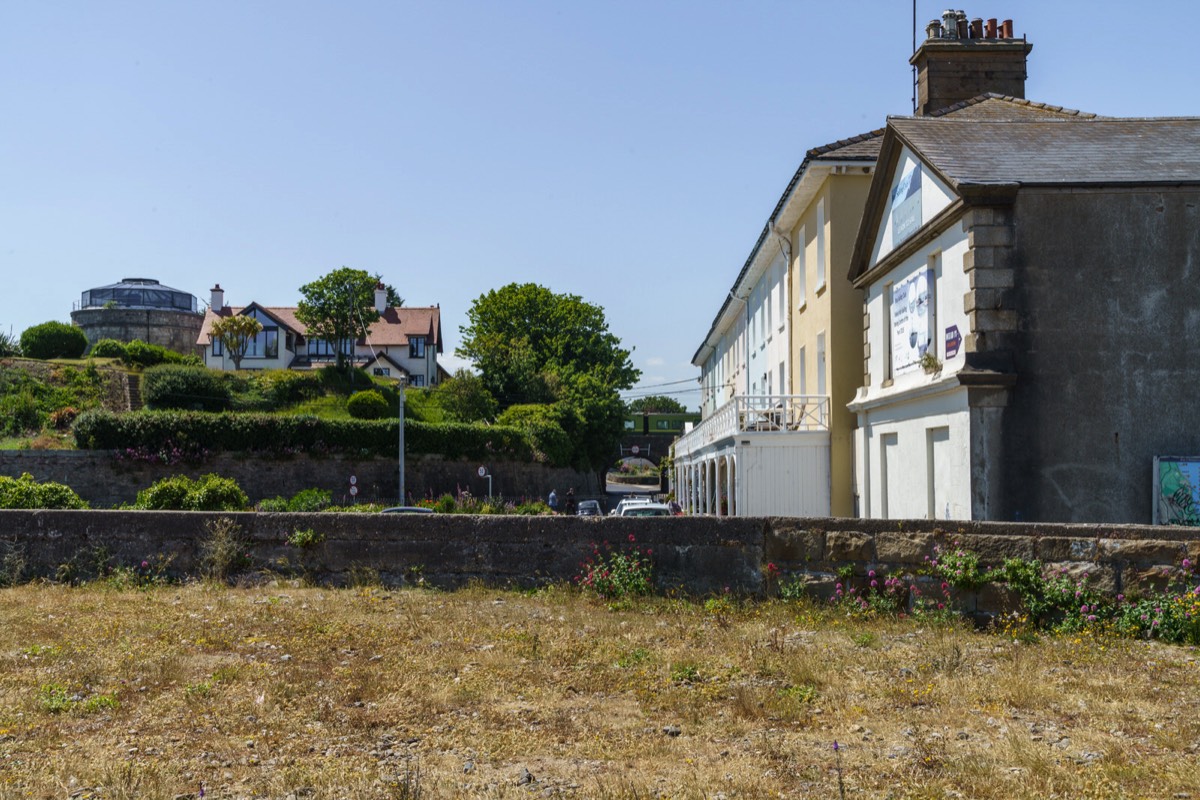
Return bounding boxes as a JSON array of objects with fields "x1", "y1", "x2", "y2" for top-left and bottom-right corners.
[{"x1": 456, "y1": 283, "x2": 641, "y2": 468}]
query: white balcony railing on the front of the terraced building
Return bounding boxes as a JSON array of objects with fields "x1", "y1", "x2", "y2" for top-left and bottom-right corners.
[{"x1": 674, "y1": 395, "x2": 829, "y2": 458}]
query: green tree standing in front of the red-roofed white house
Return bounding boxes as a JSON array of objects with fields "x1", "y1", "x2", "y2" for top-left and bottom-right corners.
[{"x1": 296, "y1": 266, "x2": 379, "y2": 369}]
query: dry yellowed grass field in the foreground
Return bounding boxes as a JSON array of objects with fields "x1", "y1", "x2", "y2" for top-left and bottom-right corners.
[{"x1": 0, "y1": 584, "x2": 1200, "y2": 800}]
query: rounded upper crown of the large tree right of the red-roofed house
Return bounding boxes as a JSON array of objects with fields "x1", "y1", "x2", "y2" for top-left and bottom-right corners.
[{"x1": 455, "y1": 283, "x2": 641, "y2": 407}]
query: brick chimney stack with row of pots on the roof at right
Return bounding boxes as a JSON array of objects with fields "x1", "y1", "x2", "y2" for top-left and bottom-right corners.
[{"x1": 908, "y1": 8, "x2": 1033, "y2": 116}]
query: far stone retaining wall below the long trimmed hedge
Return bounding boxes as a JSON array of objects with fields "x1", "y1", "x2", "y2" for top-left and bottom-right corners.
[{"x1": 0, "y1": 450, "x2": 602, "y2": 507}]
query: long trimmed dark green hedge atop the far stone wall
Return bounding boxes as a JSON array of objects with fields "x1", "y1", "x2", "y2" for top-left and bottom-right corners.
[{"x1": 72, "y1": 409, "x2": 542, "y2": 461}]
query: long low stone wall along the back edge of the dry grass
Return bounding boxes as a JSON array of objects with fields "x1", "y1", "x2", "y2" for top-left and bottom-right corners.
[{"x1": 0, "y1": 511, "x2": 1200, "y2": 615}]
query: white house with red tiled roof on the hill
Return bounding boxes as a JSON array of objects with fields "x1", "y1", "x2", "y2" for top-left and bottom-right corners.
[{"x1": 197, "y1": 283, "x2": 446, "y2": 386}]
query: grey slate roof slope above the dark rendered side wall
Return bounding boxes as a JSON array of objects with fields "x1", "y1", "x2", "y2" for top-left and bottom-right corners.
[{"x1": 888, "y1": 116, "x2": 1200, "y2": 186}]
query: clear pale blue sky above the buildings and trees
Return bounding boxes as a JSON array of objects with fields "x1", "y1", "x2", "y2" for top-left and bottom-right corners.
[{"x1": 0, "y1": 0, "x2": 1200, "y2": 407}]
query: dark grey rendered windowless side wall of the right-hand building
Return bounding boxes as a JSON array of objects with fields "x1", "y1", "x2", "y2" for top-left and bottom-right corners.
[{"x1": 998, "y1": 186, "x2": 1200, "y2": 523}]
